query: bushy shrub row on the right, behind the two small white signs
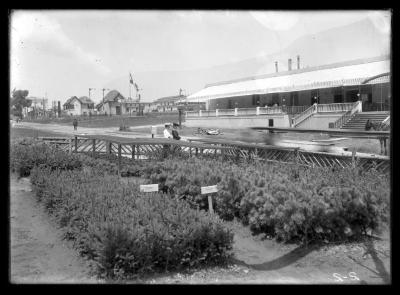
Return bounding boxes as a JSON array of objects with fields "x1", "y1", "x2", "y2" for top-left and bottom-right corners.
[{"x1": 139, "y1": 158, "x2": 390, "y2": 241}]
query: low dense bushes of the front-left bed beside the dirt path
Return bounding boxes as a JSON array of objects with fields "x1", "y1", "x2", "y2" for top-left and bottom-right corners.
[{"x1": 31, "y1": 167, "x2": 233, "y2": 278}]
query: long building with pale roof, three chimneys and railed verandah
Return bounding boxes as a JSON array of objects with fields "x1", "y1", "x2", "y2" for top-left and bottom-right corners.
[{"x1": 186, "y1": 56, "x2": 391, "y2": 127}]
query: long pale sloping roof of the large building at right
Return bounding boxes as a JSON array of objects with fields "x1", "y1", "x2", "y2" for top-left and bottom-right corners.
[{"x1": 188, "y1": 56, "x2": 390, "y2": 101}]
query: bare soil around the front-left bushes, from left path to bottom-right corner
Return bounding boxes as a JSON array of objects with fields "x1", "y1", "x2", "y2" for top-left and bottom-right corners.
[{"x1": 10, "y1": 176, "x2": 391, "y2": 284}]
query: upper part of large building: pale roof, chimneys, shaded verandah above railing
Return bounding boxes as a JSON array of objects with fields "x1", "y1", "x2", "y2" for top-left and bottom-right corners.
[{"x1": 188, "y1": 56, "x2": 390, "y2": 111}]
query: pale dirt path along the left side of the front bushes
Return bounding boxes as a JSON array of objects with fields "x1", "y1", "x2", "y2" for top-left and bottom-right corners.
[{"x1": 10, "y1": 176, "x2": 101, "y2": 283}]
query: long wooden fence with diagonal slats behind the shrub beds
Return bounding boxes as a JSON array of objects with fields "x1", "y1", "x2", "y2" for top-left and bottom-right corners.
[{"x1": 39, "y1": 135, "x2": 390, "y2": 172}]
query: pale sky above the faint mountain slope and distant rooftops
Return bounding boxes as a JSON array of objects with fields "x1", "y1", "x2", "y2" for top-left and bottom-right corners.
[{"x1": 10, "y1": 10, "x2": 391, "y2": 102}]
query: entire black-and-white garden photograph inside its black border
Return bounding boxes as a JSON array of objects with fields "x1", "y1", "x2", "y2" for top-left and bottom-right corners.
[{"x1": 8, "y1": 8, "x2": 394, "y2": 285}]
